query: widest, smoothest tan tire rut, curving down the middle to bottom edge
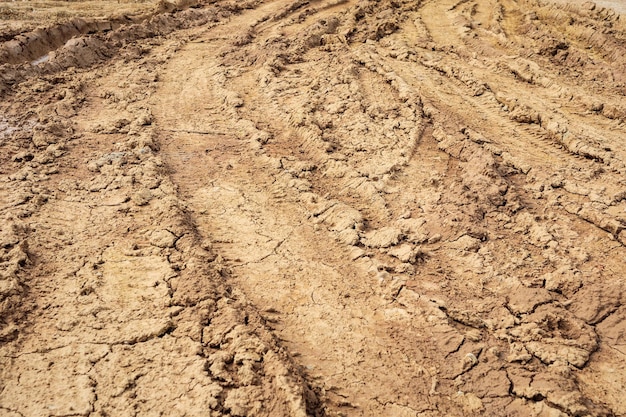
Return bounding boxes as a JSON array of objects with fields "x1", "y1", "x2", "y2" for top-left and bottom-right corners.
[{"x1": 156, "y1": 4, "x2": 468, "y2": 415}]
